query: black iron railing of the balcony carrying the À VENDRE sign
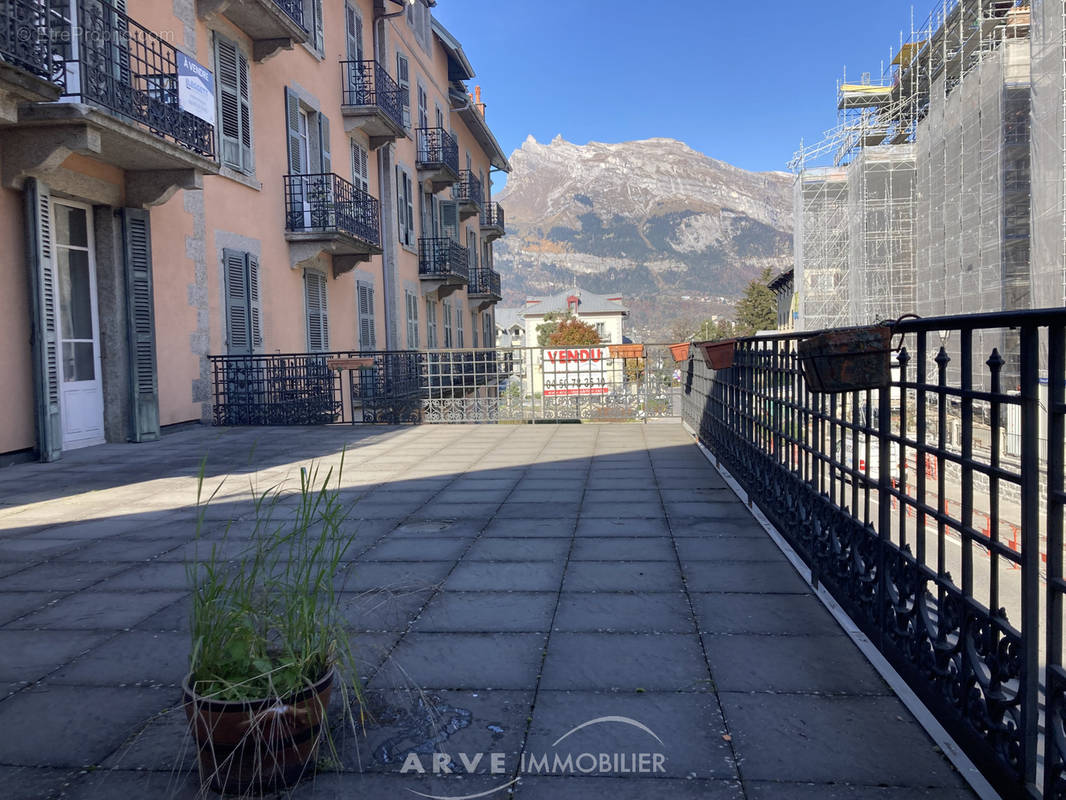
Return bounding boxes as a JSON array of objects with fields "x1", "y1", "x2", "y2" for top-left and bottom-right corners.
[{"x1": 50, "y1": 0, "x2": 214, "y2": 158}]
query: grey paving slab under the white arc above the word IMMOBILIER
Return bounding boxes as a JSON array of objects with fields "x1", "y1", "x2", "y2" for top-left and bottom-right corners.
[{"x1": 526, "y1": 691, "x2": 739, "y2": 780}]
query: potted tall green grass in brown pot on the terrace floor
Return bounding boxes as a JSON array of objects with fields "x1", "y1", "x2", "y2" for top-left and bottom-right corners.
[{"x1": 182, "y1": 457, "x2": 361, "y2": 795}]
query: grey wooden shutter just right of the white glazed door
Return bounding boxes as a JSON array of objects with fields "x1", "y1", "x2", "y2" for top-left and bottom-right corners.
[{"x1": 123, "y1": 208, "x2": 159, "y2": 442}]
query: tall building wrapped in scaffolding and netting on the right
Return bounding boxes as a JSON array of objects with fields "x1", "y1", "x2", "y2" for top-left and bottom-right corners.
[{"x1": 792, "y1": 0, "x2": 1048, "y2": 370}]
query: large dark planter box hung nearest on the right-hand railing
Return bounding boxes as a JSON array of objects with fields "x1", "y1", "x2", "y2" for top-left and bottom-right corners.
[{"x1": 796, "y1": 325, "x2": 892, "y2": 391}]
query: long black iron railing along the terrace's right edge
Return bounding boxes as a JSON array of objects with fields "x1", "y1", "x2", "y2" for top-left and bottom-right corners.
[{"x1": 684, "y1": 309, "x2": 1066, "y2": 798}]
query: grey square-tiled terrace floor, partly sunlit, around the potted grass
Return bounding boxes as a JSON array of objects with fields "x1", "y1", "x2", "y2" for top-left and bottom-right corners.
[{"x1": 0, "y1": 425, "x2": 970, "y2": 800}]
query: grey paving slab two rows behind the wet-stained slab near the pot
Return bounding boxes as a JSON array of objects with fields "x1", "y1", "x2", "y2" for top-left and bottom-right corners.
[{"x1": 411, "y1": 592, "x2": 559, "y2": 633}]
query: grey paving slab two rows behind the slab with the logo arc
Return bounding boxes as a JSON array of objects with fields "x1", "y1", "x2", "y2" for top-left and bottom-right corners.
[{"x1": 554, "y1": 597, "x2": 695, "y2": 634}]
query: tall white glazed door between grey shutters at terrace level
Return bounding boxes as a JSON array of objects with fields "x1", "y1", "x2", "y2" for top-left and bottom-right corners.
[{"x1": 52, "y1": 201, "x2": 103, "y2": 450}]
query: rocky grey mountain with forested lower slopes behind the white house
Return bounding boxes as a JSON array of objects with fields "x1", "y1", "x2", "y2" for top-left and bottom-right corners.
[{"x1": 496, "y1": 137, "x2": 792, "y2": 336}]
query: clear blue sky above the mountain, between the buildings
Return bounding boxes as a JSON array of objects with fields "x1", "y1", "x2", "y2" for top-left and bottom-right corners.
[{"x1": 434, "y1": 0, "x2": 916, "y2": 170}]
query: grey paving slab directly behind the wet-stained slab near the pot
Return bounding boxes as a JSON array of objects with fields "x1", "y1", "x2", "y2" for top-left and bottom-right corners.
[{"x1": 368, "y1": 633, "x2": 547, "y2": 691}]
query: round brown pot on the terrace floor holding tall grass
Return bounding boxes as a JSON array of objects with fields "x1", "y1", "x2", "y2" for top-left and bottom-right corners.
[{"x1": 182, "y1": 669, "x2": 336, "y2": 795}]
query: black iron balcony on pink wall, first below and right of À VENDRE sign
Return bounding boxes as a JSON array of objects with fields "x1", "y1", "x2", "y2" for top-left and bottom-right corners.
[{"x1": 285, "y1": 173, "x2": 382, "y2": 273}]
